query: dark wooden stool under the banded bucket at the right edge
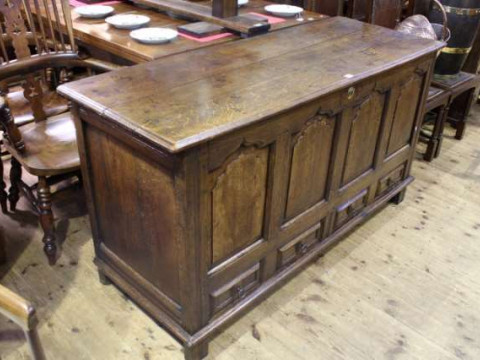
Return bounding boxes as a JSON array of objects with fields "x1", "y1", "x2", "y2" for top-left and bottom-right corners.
[{"x1": 432, "y1": 71, "x2": 480, "y2": 140}]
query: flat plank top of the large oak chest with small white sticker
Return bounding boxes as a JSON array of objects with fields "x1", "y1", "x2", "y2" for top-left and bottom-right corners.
[{"x1": 59, "y1": 17, "x2": 442, "y2": 152}]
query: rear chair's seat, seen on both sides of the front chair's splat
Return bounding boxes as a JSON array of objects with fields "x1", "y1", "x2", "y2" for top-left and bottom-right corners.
[{"x1": 7, "y1": 89, "x2": 68, "y2": 126}]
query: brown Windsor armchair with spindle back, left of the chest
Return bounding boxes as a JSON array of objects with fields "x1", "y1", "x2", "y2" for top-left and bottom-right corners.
[{"x1": 0, "y1": 0, "x2": 116, "y2": 264}]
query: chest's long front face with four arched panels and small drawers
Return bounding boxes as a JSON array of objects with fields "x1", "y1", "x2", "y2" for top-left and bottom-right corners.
[{"x1": 199, "y1": 60, "x2": 430, "y2": 318}]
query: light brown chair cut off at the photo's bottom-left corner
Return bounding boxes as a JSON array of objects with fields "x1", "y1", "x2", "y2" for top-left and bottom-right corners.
[{"x1": 0, "y1": 231, "x2": 45, "y2": 360}]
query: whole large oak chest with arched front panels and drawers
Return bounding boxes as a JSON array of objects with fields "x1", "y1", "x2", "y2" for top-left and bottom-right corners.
[{"x1": 59, "y1": 17, "x2": 442, "y2": 359}]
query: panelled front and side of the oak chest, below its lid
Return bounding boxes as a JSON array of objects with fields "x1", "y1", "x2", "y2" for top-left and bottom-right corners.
[{"x1": 73, "y1": 54, "x2": 431, "y2": 354}]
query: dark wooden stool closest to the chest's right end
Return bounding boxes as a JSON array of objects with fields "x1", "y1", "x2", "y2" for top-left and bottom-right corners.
[{"x1": 420, "y1": 86, "x2": 451, "y2": 161}]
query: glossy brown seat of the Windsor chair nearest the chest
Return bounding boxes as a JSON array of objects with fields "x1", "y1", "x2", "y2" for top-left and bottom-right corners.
[{"x1": 5, "y1": 113, "x2": 80, "y2": 176}]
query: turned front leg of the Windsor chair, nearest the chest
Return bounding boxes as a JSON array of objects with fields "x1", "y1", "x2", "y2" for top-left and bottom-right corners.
[{"x1": 37, "y1": 176, "x2": 57, "y2": 265}]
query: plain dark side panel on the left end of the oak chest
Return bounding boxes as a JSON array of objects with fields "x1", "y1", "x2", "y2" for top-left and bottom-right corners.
[{"x1": 83, "y1": 122, "x2": 181, "y2": 317}]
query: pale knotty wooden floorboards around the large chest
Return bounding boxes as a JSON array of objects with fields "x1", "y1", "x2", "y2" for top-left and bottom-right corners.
[{"x1": 0, "y1": 108, "x2": 480, "y2": 360}]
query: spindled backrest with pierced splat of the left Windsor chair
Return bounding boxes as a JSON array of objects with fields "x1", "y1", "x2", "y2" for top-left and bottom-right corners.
[{"x1": 0, "y1": 0, "x2": 78, "y2": 122}]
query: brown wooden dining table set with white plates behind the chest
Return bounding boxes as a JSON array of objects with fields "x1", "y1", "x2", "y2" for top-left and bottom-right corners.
[{"x1": 38, "y1": 0, "x2": 326, "y2": 65}]
